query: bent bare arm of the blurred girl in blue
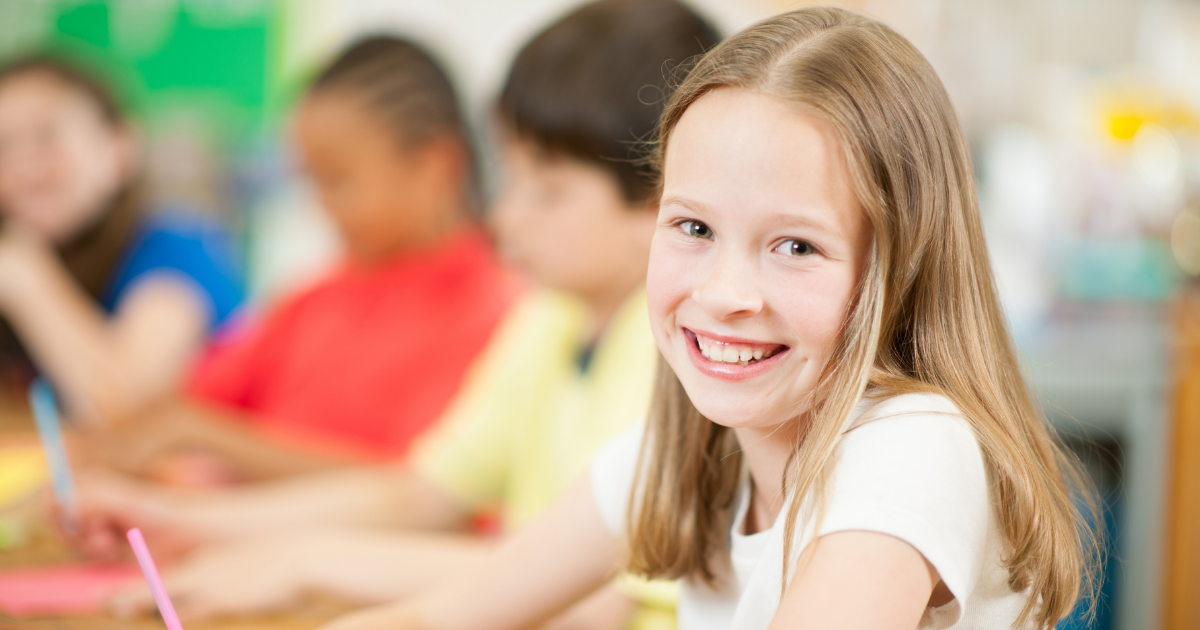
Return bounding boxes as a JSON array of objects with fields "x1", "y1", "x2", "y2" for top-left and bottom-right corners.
[{"x1": 0, "y1": 226, "x2": 209, "y2": 421}]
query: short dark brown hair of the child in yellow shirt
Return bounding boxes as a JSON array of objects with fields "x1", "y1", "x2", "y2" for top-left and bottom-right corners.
[{"x1": 497, "y1": 0, "x2": 719, "y2": 204}]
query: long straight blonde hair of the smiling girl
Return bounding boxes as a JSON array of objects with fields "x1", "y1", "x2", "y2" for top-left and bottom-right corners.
[{"x1": 626, "y1": 8, "x2": 1097, "y2": 628}]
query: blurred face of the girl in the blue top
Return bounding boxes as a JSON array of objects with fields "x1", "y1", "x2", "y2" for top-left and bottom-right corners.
[{"x1": 0, "y1": 72, "x2": 134, "y2": 242}]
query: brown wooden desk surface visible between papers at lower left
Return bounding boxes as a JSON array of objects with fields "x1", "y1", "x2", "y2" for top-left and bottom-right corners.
[{"x1": 0, "y1": 395, "x2": 350, "y2": 630}]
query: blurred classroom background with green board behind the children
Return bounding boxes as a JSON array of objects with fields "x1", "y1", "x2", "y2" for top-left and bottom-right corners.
[{"x1": 0, "y1": 0, "x2": 1200, "y2": 630}]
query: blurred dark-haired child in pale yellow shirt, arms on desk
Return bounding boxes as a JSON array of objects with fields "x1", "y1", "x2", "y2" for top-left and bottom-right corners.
[{"x1": 85, "y1": 0, "x2": 718, "y2": 628}]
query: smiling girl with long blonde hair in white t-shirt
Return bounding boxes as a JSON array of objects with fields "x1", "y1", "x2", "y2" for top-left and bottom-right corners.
[{"x1": 321, "y1": 8, "x2": 1094, "y2": 630}]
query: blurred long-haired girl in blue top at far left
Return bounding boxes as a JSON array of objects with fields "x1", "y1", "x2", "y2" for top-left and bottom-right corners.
[{"x1": 0, "y1": 58, "x2": 241, "y2": 425}]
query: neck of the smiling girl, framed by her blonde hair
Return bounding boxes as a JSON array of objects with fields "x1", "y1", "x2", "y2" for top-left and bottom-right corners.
[{"x1": 733, "y1": 420, "x2": 799, "y2": 534}]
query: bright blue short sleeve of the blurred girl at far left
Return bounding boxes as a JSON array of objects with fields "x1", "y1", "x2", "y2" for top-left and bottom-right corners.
[{"x1": 101, "y1": 211, "x2": 244, "y2": 331}]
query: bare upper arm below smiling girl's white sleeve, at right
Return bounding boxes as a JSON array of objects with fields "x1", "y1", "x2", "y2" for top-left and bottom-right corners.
[{"x1": 764, "y1": 532, "x2": 940, "y2": 630}]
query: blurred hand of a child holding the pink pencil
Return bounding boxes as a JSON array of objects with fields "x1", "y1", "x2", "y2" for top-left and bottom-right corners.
[{"x1": 108, "y1": 538, "x2": 306, "y2": 620}]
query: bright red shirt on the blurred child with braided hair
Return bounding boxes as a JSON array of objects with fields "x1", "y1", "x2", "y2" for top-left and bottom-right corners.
[{"x1": 188, "y1": 228, "x2": 518, "y2": 457}]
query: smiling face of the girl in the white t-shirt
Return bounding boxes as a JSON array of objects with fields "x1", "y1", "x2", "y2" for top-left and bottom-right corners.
[{"x1": 647, "y1": 88, "x2": 871, "y2": 427}]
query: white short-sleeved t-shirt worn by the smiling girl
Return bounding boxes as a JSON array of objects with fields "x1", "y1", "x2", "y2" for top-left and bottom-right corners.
[{"x1": 590, "y1": 394, "x2": 1033, "y2": 630}]
